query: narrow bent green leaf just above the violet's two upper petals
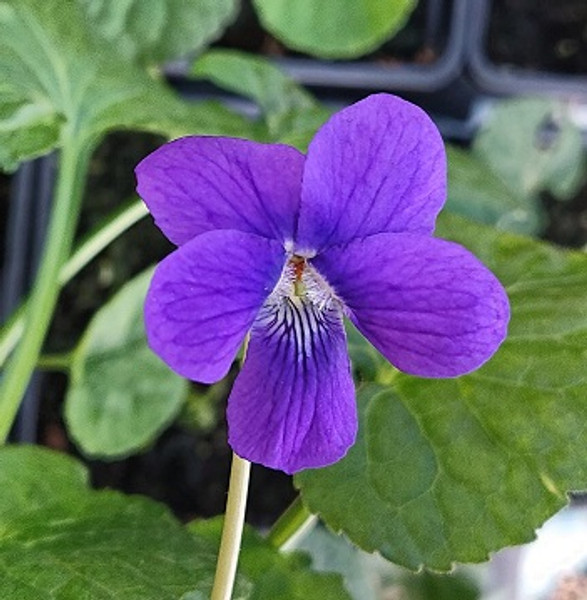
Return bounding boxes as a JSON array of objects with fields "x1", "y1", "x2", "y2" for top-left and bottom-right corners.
[{"x1": 192, "y1": 50, "x2": 330, "y2": 144}]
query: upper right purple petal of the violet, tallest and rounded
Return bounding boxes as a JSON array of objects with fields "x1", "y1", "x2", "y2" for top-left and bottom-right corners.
[{"x1": 296, "y1": 94, "x2": 446, "y2": 251}]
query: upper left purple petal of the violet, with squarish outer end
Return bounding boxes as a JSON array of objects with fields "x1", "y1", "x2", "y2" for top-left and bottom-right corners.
[{"x1": 135, "y1": 137, "x2": 304, "y2": 245}]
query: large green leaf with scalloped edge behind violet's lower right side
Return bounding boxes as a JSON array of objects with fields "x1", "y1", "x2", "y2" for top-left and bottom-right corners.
[{"x1": 296, "y1": 215, "x2": 587, "y2": 570}]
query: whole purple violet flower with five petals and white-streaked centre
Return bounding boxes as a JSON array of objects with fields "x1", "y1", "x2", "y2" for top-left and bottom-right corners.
[{"x1": 136, "y1": 94, "x2": 509, "y2": 473}]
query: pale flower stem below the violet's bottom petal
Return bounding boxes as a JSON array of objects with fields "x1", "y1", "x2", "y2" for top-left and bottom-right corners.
[{"x1": 211, "y1": 454, "x2": 251, "y2": 600}]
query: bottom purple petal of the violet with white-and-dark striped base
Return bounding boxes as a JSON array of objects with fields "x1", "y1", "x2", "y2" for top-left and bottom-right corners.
[{"x1": 227, "y1": 299, "x2": 357, "y2": 473}]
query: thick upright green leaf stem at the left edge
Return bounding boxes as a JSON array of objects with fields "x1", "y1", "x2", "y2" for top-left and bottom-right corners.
[{"x1": 0, "y1": 139, "x2": 91, "y2": 443}]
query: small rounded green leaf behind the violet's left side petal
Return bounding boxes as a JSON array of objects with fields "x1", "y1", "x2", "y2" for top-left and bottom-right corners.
[{"x1": 65, "y1": 269, "x2": 188, "y2": 458}]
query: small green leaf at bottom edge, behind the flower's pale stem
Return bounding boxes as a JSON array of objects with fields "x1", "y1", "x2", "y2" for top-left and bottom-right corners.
[{"x1": 189, "y1": 518, "x2": 351, "y2": 600}]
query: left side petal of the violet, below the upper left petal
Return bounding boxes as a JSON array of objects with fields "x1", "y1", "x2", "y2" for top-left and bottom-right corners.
[{"x1": 145, "y1": 231, "x2": 285, "y2": 383}]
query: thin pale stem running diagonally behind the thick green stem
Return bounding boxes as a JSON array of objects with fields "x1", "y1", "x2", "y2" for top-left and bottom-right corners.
[{"x1": 0, "y1": 199, "x2": 147, "y2": 367}]
